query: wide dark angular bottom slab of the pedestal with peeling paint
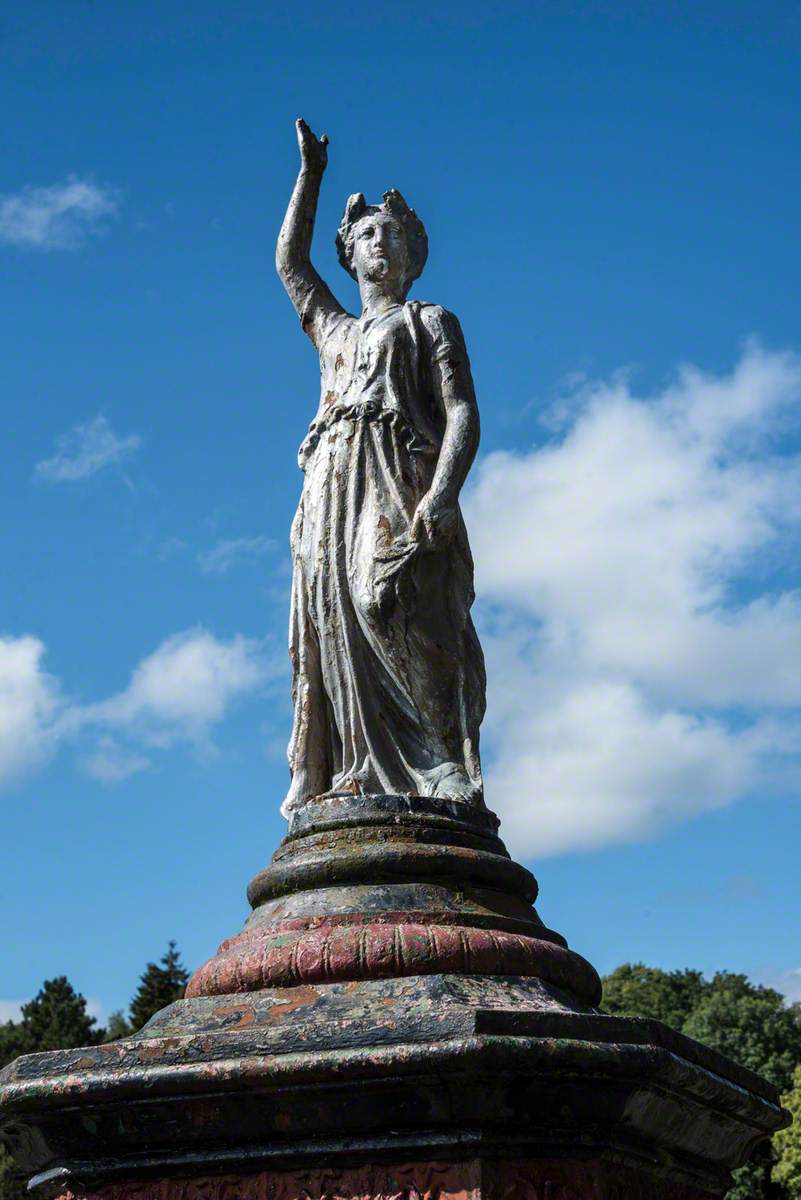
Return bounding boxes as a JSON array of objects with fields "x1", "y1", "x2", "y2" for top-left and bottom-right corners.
[{"x1": 2, "y1": 976, "x2": 782, "y2": 1200}]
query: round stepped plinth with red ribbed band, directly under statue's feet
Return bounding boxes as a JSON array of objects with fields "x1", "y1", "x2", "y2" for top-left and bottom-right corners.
[{"x1": 187, "y1": 793, "x2": 601, "y2": 1004}]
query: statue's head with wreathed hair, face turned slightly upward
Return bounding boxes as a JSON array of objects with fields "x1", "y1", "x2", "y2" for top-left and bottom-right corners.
[{"x1": 337, "y1": 190, "x2": 428, "y2": 296}]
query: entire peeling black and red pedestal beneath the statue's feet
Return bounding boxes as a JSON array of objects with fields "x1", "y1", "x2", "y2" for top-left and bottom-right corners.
[{"x1": 0, "y1": 796, "x2": 784, "y2": 1200}]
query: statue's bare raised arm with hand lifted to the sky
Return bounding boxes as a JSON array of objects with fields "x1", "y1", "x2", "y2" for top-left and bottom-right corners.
[{"x1": 276, "y1": 118, "x2": 343, "y2": 342}]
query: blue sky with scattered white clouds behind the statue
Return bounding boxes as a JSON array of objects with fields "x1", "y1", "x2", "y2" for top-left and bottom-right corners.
[{"x1": 0, "y1": 0, "x2": 801, "y2": 1027}]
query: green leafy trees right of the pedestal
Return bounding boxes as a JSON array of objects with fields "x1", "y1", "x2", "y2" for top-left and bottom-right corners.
[{"x1": 603, "y1": 962, "x2": 801, "y2": 1200}]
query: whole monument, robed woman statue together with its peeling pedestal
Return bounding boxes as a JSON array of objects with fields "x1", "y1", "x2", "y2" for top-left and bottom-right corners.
[{"x1": 0, "y1": 122, "x2": 789, "y2": 1200}]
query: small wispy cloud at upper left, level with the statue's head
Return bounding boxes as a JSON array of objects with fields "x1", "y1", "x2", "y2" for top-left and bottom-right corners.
[{"x1": 0, "y1": 175, "x2": 118, "y2": 250}]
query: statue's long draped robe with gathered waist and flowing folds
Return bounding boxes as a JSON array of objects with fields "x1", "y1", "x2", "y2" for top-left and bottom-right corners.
[{"x1": 289, "y1": 289, "x2": 486, "y2": 806}]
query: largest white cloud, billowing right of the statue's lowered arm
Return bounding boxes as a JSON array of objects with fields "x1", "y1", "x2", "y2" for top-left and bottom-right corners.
[{"x1": 465, "y1": 344, "x2": 801, "y2": 856}]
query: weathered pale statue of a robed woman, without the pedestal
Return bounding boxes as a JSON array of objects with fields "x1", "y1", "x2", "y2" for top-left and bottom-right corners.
[{"x1": 276, "y1": 120, "x2": 486, "y2": 816}]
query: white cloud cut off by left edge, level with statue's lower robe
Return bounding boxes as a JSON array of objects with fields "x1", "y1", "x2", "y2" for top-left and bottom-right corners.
[{"x1": 0, "y1": 637, "x2": 59, "y2": 782}]
